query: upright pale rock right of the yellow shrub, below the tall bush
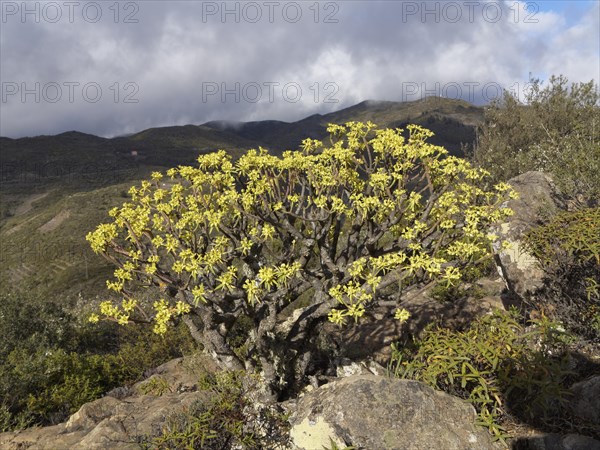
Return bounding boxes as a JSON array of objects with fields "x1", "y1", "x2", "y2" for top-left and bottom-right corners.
[{"x1": 494, "y1": 172, "x2": 566, "y2": 298}]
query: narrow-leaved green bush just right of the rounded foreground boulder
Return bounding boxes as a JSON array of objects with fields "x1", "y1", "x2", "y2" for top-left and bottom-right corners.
[{"x1": 390, "y1": 311, "x2": 569, "y2": 441}]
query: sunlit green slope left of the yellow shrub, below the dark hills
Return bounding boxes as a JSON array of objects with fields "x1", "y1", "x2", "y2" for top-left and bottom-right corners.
[{"x1": 0, "y1": 182, "x2": 131, "y2": 303}]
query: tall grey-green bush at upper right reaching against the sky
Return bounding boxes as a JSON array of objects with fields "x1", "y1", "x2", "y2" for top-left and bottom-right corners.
[{"x1": 474, "y1": 76, "x2": 600, "y2": 205}]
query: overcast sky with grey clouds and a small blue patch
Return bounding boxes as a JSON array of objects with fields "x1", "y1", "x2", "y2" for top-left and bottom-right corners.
[{"x1": 0, "y1": 0, "x2": 600, "y2": 137}]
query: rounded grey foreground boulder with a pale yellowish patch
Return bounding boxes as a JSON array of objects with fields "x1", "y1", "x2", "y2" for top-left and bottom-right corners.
[{"x1": 291, "y1": 375, "x2": 502, "y2": 450}]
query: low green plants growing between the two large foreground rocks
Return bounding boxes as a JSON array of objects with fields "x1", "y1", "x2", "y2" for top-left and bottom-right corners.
[{"x1": 143, "y1": 372, "x2": 289, "y2": 450}]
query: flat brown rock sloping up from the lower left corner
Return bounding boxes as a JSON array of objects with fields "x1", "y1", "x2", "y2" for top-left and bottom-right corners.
[{"x1": 0, "y1": 354, "x2": 216, "y2": 450}]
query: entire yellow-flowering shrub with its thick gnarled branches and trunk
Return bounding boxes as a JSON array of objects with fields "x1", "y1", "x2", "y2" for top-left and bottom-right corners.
[{"x1": 87, "y1": 122, "x2": 514, "y2": 395}]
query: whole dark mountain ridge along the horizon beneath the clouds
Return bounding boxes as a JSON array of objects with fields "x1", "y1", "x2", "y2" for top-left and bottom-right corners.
[{"x1": 0, "y1": 97, "x2": 483, "y2": 189}]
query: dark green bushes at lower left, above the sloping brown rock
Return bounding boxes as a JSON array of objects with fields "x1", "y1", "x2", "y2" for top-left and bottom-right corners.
[{"x1": 0, "y1": 293, "x2": 194, "y2": 431}]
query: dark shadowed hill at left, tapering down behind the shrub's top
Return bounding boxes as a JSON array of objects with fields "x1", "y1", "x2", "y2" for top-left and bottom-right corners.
[{"x1": 0, "y1": 125, "x2": 257, "y2": 189}]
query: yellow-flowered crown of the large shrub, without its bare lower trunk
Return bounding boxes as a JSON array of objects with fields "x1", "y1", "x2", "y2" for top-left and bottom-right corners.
[{"x1": 87, "y1": 122, "x2": 514, "y2": 333}]
